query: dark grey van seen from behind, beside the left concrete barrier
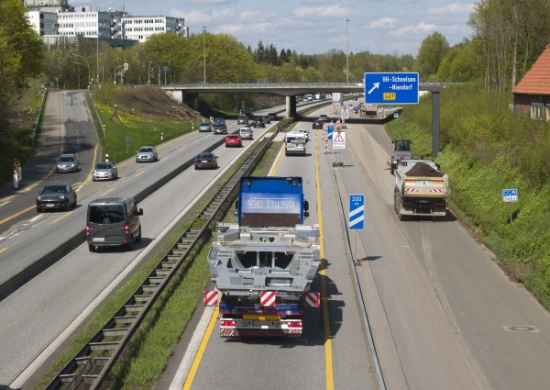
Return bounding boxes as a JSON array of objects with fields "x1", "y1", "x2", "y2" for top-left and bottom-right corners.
[{"x1": 86, "y1": 197, "x2": 143, "y2": 252}]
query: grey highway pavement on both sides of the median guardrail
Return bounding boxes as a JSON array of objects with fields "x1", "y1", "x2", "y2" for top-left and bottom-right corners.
[{"x1": 0, "y1": 91, "x2": 550, "y2": 389}]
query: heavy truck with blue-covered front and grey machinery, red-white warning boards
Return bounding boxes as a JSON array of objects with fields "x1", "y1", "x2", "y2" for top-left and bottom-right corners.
[{"x1": 204, "y1": 176, "x2": 320, "y2": 337}]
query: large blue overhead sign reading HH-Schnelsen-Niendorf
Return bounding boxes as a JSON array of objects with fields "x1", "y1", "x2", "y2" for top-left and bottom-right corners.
[{"x1": 365, "y1": 72, "x2": 418, "y2": 104}]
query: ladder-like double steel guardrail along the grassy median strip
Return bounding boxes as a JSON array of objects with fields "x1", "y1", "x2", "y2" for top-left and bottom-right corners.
[{"x1": 46, "y1": 136, "x2": 277, "y2": 390}]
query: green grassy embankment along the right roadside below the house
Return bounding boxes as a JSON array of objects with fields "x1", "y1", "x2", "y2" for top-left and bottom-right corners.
[{"x1": 387, "y1": 85, "x2": 550, "y2": 309}]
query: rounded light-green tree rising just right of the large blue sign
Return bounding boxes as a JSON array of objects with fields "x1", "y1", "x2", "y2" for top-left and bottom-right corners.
[{"x1": 416, "y1": 31, "x2": 449, "y2": 80}]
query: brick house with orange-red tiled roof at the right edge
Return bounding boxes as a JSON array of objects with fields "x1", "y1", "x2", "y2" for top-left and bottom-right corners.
[{"x1": 512, "y1": 45, "x2": 550, "y2": 121}]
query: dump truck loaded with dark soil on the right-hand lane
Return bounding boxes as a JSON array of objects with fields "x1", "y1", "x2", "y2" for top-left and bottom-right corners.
[{"x1": 393, "y1": 160, "x2": 451, "y2": 221}]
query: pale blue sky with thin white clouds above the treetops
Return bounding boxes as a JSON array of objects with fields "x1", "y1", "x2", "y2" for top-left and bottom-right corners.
[{"x1": 69, "y1": 0, "x2": 476, "y2": 57}]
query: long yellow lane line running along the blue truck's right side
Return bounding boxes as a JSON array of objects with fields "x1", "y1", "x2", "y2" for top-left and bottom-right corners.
[{"x1": 315, "y1": 133, "x2": 334, "y2": 390}]
